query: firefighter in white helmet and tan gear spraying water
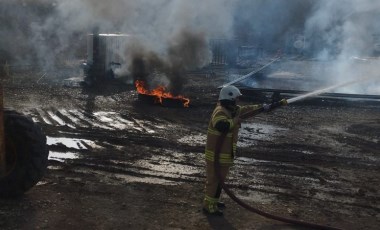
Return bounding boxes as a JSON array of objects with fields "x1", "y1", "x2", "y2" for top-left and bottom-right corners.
[{"x1": 203, "y1": 85, "x2": 287, "y2": 216}]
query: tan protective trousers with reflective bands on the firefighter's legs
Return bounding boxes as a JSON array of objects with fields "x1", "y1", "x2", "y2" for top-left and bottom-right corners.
[{"x1": 203, "y1": 160, "x2": 230, "y2": 213}]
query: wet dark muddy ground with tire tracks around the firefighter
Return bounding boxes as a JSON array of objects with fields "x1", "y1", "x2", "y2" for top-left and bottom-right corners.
[{"x1": 0, "y1": 67, "x2": 380, "y2": 230}]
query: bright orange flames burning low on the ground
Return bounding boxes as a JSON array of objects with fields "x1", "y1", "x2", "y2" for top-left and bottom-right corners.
[{"x1": 135, "y1": 80, "x2": 190, "y2": 107}]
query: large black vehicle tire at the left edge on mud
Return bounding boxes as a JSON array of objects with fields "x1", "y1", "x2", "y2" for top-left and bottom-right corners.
[{"x1": 0, "y1": 110, "x2": 49, "y2": 197}]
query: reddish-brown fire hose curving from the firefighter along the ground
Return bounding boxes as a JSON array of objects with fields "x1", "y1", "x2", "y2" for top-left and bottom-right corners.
[{"x1": 214, "y1": 108, "x2": 340, "y2": 230}]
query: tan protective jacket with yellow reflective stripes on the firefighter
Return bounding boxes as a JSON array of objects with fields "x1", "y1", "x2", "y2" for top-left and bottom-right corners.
[{"x1": 205, "y1": 104, "x2": 263, "y2": 166}]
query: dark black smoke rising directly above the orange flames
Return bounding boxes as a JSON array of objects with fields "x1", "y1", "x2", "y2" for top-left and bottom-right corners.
[{"x1": 126, "y1": 31, "x2": 210, "y2": 95}]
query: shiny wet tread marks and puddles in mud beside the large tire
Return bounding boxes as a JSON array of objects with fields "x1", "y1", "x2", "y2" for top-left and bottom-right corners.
[{"x1": 23, "y1": 108, "x2": 168, "y2": 164}]
